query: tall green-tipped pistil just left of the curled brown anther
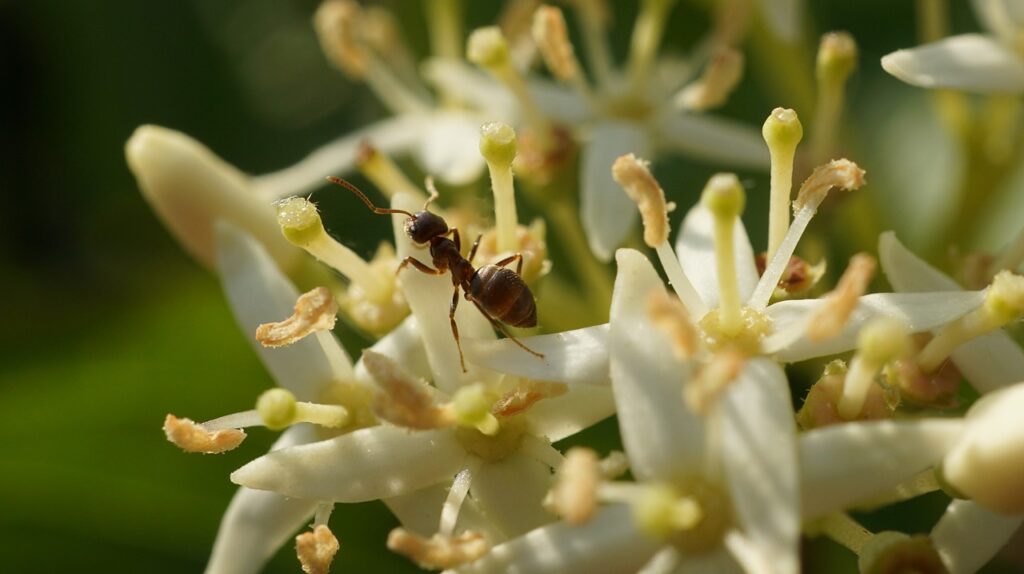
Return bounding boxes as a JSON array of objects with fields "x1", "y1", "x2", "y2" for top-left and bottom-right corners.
[{"x1": 761, "y1": 107, "x2": 804, "y2": 261}]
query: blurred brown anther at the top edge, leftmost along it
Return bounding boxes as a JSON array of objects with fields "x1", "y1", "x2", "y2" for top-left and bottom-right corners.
[{"x1": 313, "y1": 0, "x2": 370, "y2": 78}]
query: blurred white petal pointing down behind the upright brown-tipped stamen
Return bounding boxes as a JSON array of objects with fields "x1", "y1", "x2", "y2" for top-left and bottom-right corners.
[{"x1": 580, "y1": 122, "x2": 651, "y2": 261}]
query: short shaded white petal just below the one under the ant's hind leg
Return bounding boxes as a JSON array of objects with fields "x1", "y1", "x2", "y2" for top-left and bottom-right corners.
[{"x1": 526, "y1": 386, "x2": 615, "y2": 442}]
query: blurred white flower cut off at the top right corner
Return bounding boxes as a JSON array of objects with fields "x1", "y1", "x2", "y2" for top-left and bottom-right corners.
[{"x1": 882, "y1": 0, "x2": 1024, "y2": 93}]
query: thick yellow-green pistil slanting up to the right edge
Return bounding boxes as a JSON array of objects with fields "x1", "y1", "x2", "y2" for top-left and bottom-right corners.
[{"x1": 918, "y1": 271, "x2": 1024, "y2": 372}]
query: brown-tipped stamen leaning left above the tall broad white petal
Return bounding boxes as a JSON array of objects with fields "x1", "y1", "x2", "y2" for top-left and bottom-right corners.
[{"x1": 611, "y1": 153, "x2": 707, "y2": 317}]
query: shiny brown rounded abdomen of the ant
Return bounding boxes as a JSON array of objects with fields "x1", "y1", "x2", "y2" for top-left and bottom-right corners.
[{"x1": 469, "y1": 265, "x2": 537, "y2": 327}]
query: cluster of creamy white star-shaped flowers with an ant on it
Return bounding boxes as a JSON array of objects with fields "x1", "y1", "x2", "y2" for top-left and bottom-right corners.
[{"x1": 126, "y1": 0, "x2": 1024, "y2": 574}]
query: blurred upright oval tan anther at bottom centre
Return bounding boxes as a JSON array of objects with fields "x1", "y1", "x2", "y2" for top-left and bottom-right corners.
[{"x1": 550, "y1": 446, "x2": 603, "y2": 524}]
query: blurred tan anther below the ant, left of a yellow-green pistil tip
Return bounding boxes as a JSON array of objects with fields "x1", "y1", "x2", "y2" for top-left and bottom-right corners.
[{"x1": 362, "y1": 349, "x2": 456, "y2": 430}]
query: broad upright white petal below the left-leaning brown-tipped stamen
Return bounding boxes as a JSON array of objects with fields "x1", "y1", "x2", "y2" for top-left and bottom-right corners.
[{"x1": 608, "y1": 249, "x2": 705, "y2": 480}]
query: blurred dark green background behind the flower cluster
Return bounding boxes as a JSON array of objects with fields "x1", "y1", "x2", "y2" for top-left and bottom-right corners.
[{"x1": 0, "y1": 0, "x2": 1021, "y2": 572}]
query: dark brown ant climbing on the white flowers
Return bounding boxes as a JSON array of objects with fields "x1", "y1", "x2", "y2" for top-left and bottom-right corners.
[{"x1": 327, "y1": 177, "x2": 544, "y2": 372}]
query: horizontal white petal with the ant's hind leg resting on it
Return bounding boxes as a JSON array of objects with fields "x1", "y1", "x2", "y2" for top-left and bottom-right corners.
[{"x1": 462, "y1": 323, "x2": 610, "y2": 386}]
